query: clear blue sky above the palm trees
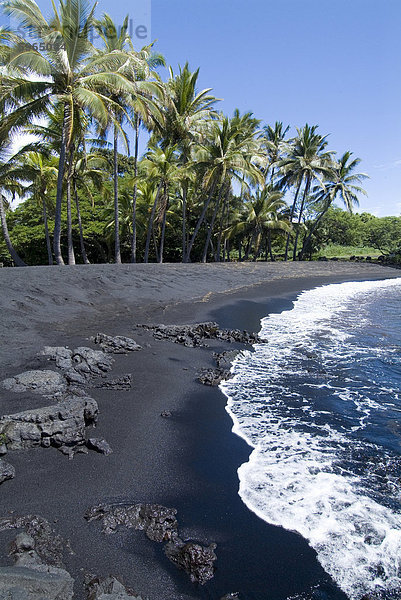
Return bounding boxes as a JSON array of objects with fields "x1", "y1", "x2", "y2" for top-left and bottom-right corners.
[{"x1": 1, "y1": 0, "x2": 401, "y2": 216}]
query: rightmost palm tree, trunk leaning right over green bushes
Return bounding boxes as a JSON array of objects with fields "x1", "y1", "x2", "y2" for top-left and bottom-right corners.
[{"x1": 299, "y1": 151, "x2": 368, "y2": 260}]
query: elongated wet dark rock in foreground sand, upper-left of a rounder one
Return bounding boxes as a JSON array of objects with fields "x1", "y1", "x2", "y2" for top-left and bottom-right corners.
[{"x1": 85, "y1": 504, "x2": 178, "y2": 542}]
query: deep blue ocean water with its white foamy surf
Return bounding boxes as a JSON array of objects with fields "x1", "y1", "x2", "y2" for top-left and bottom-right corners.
[{"x1": 221, "y1": 279, "x2": 401, "y2": 600}]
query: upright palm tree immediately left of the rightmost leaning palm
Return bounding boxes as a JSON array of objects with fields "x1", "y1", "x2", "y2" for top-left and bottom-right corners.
[{"x1": 279, "y1": 124, "x2": 333, "y2": 260}]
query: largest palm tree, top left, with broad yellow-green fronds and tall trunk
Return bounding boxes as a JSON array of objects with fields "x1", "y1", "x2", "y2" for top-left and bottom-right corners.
[{"x1": 0, "y1": 0, "x2": 140, "y2": 264}]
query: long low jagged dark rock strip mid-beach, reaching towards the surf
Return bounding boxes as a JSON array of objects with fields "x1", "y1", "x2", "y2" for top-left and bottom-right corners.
[{"x1": 138, "y1": 321, "x2": 259, "y2": 347}]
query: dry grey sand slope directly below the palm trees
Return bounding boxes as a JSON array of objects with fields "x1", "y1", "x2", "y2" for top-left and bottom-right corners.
[{"x1": 0, "y1": 262, "x2": 399, "y2": 373}]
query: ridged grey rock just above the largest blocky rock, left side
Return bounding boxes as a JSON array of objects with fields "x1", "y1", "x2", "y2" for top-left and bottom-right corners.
[{"x1": 42, "y1": 346, "x2": 114, "y2": 385}]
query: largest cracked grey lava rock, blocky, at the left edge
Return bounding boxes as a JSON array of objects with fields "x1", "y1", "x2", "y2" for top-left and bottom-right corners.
[{"x1": 0, "y1": 396, "x2": 98, "y2": 450}]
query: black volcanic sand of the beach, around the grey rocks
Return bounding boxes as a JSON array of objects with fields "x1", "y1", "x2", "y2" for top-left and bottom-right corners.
[{"x1": 0, "y1": 263, "x2": 399, "y2": 600}]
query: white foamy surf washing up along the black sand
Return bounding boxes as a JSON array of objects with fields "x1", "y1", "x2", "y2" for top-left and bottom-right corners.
[{"x1": 221, "y1": 279, "x2": 401, "y2": 600}]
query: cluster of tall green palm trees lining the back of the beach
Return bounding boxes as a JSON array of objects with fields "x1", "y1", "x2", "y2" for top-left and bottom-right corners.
[{"x1": 0, "y1": 0, "x2": 366, "y2": 265}]
